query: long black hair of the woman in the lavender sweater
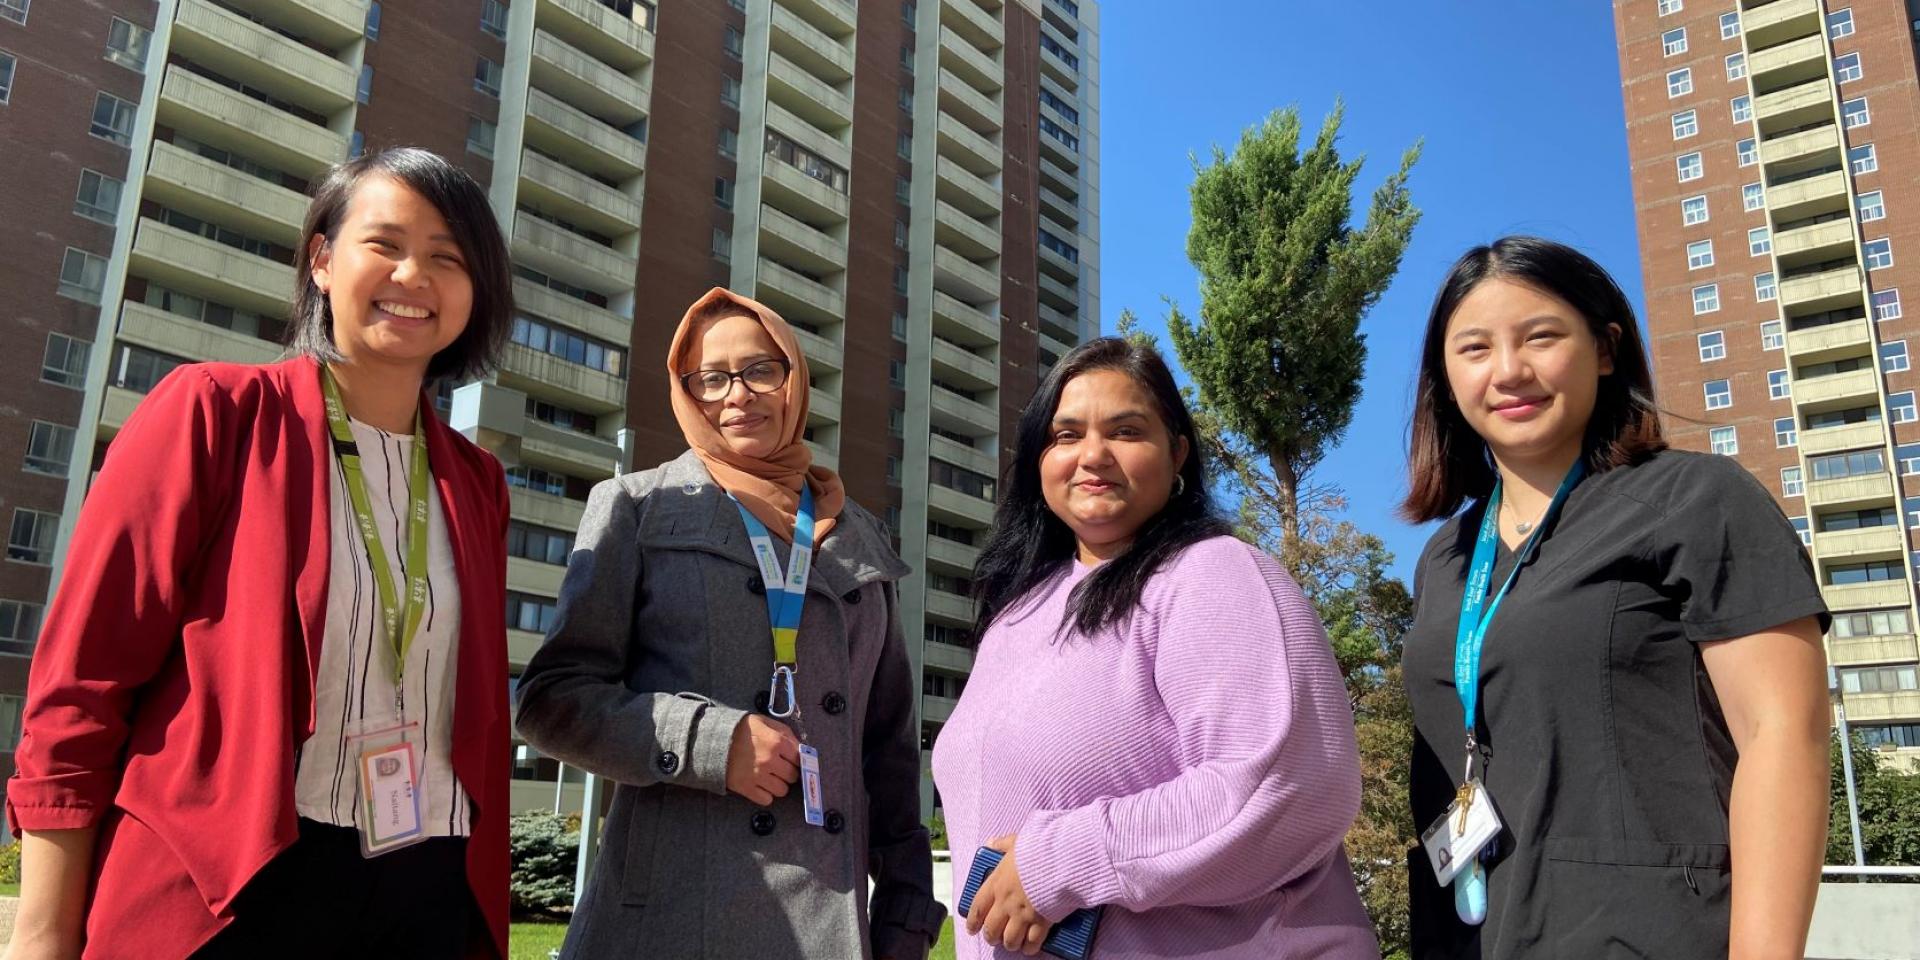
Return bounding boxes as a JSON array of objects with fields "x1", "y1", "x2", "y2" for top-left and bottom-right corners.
[{"x1": 972, "y1": 336, "x2": 1231, "y2": 643}]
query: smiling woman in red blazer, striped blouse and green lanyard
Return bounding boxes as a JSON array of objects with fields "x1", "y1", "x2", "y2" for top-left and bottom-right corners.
[{"x1": 6, "y1": 150, "x2": 513, "y2": 960}]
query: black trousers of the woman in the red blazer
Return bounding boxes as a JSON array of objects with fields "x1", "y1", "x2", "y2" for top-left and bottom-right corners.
[{"x1": 194, "y1": 818, "x2": 484, "y2": 960}]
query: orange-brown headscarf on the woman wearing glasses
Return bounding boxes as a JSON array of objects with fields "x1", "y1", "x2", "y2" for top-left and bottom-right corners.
[{"x1": 666, "y1": 286, "x2": 847, "y2": 543}]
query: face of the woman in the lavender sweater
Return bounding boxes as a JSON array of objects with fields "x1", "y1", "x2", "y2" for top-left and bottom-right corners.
[{"x1": 1041, "y1": 371, "x2": 1187, "y2": 553}]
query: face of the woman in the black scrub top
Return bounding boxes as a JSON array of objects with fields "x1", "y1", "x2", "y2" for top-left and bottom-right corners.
[{"x1": 1446, "y1": 278, "x2": 1620, "y2": 470}]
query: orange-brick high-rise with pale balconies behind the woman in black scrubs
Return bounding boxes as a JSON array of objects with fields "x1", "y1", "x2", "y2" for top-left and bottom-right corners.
[{"x1": 1613, "y1": 0, "x2": 1920, "y2": 762}]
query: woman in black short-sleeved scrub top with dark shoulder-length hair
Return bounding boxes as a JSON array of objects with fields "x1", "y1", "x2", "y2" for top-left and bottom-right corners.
[{"x1": 1402, "y1": 236, "x2": 1828, "y2": 960}]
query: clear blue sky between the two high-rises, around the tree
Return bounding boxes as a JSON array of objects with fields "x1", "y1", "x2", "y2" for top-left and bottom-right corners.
[{"x1": 1100, "y1": 0, "x2": 1644, "y2": 578}]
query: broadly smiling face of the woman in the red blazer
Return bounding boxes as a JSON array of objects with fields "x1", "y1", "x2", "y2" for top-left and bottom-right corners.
[{"x1": 307, "y1": 175, "x2": 474, "y2": 372}]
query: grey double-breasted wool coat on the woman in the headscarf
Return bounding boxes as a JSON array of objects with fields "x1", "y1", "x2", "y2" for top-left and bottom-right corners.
[{"x1": 516, "y1": 453, "x2": 947, "y2": 960}]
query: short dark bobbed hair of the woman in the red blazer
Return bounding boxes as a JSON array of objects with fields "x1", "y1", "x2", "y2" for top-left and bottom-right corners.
[{"x1": 286, "y1": 146, "x2": 513, "y2": 380}]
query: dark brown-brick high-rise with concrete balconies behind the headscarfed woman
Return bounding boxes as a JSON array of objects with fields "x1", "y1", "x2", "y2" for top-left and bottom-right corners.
[{"x1": 0, "y1": 0, "x2": 1098, "y2": 806}]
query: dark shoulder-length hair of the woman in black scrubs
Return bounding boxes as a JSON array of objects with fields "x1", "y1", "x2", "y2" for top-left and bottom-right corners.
[{"x1": 1400, "y1": 236, "x2": 1667, "y2": 522}]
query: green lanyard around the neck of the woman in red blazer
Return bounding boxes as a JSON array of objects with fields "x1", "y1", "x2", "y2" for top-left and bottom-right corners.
[{"x1": 321, "y1": 365, "x2": 430, "y2": 708}]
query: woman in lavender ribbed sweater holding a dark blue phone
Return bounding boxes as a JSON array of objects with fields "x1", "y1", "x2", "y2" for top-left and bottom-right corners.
[{"x1": 933, "y1": 338, "x2": 1379, "y2": 960}]
